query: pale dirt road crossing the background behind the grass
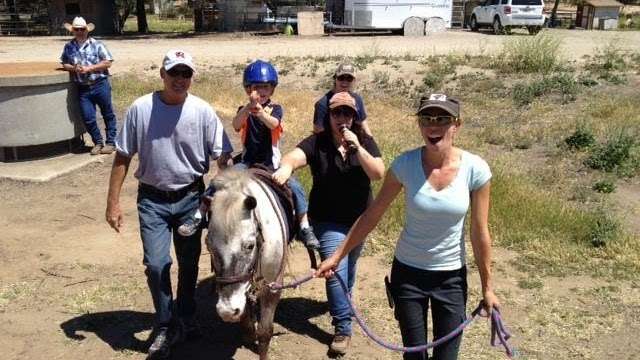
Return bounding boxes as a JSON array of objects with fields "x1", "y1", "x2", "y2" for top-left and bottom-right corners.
[{"x1": 0, "y1": 30, "x2": 640, "y2": 74}]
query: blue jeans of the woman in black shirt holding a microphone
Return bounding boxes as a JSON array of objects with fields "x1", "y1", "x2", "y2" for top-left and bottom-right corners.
[{"x1": 313, "y1": 222, "x2": 362, "y2": 336}]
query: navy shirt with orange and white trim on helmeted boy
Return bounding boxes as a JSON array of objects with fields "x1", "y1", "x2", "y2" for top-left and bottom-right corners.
[{"x1": 239, "y1": 100, "x2": 284, "y2": 169}]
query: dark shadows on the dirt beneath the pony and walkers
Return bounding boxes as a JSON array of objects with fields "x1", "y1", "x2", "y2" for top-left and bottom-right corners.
[{"x1": 60, "y1": 278, "x2": 332, "y2": 360}]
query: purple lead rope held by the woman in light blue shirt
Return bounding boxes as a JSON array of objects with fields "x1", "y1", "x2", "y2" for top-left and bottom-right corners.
[{"x1": 269, "y1": 273, "x2": 514, "y2": 358}]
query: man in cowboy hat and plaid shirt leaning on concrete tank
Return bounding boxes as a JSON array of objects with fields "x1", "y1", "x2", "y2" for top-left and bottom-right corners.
[{"x1": 60, "y1": 16, "x2": 117, "y2": 155}]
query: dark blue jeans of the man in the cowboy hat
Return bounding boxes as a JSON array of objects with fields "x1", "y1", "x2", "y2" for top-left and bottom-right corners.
[{"x1": 78, "y1": 79, "x2": 117, "y2": 145}]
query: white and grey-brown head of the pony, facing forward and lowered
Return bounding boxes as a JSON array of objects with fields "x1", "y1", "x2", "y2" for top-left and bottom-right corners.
[{"x1": 206, "y1": 169, "x2": 262, "y2": 322}]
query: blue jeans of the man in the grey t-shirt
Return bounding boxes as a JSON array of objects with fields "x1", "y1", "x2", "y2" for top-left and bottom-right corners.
[{"x1": 138, "y1": 184, "x2": 202, "y2": 327}]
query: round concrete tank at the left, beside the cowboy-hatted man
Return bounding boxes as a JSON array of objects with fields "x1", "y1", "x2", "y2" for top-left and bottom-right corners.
[{"x1": 0, "y1": 62, "x2": 84, "y2": 162}]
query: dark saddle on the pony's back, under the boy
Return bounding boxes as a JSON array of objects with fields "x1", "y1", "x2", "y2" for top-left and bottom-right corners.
[{"x1": 249, "y1": 164, "x2": 300, "y2": 243}]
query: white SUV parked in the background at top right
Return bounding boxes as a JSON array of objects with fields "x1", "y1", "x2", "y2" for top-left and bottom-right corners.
[{"x1": 469, "y1": 0, "x2": 545, "y2": 35}]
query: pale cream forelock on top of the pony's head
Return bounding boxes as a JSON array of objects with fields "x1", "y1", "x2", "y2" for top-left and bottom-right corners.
[{"x1": 210, "y1": 168, "x2": 251, "y2": 238}]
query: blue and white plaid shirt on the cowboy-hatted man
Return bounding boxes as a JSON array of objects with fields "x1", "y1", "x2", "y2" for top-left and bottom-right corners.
[{"x1": 60, "y1": 37, "x2": 113, "y2": 84}]
